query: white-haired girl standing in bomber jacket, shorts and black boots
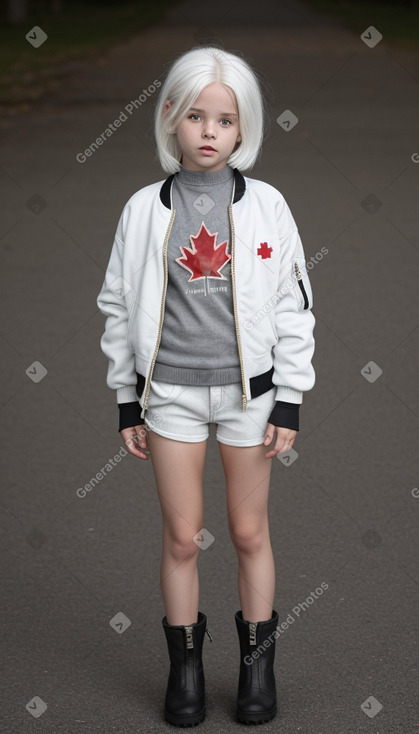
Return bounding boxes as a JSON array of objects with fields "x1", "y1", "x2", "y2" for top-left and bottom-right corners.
[{"x1": 97, "y1": 47, "x2": 315, "y2": 726}]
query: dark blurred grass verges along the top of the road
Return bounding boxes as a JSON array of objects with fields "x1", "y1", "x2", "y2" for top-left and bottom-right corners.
[{"x1": 0, "y1": 0, "x2": 419, "y2": 111}]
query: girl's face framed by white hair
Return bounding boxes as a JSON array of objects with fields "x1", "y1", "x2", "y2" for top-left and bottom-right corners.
[{"x1": 164, "y1": 82, "x2": 241, "y2": 171}]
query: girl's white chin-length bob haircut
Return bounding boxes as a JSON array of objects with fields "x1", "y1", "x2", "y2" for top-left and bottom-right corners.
[{"x1": 154, "y1": 46, "x2": 268, "y2": 173}]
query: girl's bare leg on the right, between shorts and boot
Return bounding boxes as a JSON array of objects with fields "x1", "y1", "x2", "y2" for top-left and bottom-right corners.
[{"x1": 219, "y1": 442, "x2": 275, "y2": 622}]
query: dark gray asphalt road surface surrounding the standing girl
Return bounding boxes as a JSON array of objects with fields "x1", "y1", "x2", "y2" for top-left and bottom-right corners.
[{"x1": 0, "y1": 0, "x2": 419, "y2": 734}]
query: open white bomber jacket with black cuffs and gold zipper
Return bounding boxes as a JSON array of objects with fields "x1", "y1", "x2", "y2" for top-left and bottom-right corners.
[{"x1": 97, "y1": 168, "x2": 315, "y2": 431}]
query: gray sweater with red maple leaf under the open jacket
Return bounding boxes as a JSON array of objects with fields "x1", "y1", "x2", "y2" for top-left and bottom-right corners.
[{"x1": 153, "y1": 165, "x2": 241, "y2": 385}]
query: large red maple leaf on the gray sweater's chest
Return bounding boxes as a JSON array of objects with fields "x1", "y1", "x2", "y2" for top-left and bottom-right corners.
[{"x1": 175, "y1": 222, "x2": 231, "y2": 283}]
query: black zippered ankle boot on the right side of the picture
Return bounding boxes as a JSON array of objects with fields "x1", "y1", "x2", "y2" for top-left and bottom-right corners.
[{"x1": 236, "y1": 609, "x2": 278, "y2": 724}]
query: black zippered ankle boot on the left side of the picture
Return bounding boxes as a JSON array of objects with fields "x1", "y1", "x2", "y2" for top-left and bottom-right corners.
[{"x1": 162, "y1": 612, "x2": 212, "y2": 726}]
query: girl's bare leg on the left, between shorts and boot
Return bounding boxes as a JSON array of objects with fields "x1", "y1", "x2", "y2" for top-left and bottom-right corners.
[{"x1": 148, "y1": 431, "x2": 207, "y2": 625}]
